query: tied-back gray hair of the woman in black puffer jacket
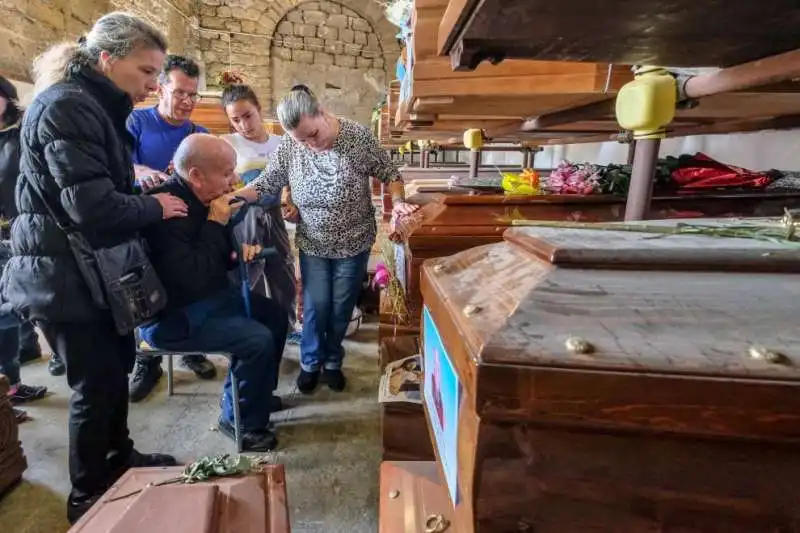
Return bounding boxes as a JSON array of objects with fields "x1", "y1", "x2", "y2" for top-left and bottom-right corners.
[{"x1": 33, "y1": 11, "x2": 167, "y2": 94}]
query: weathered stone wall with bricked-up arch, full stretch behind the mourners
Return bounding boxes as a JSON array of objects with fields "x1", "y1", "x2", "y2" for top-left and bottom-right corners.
[{"x1": 0, "y1": 0, "x2": 400, "y2": 122}]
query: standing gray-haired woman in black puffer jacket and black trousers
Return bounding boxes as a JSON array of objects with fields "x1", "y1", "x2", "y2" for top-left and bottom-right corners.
[{"x1": 2, "y1": 13, "x2": 186, "y2": 522}]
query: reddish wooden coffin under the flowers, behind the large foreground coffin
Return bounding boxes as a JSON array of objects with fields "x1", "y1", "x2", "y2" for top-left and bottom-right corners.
[{"x1": 380, "y1": 192, "x2": 800, "y2": 335}]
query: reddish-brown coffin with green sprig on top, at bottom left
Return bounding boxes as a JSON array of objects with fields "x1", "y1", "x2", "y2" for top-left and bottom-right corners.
[{"x1": 70, "y1": 465, "x2": 290, "y2": 533}]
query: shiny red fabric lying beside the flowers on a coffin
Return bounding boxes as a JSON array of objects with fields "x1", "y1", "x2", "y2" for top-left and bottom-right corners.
[{"x1": 672, "y1": 152, "x2": 772, "y2": 189}]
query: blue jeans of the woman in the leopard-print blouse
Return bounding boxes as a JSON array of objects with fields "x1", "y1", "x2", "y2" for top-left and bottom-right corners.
[{"x1": 300, "y1": 250, "x2": 369, "y2": 372}]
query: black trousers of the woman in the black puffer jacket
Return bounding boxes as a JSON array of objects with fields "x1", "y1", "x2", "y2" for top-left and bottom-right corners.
[{"x1": 40, "y1": 319, "x2": 136, "y2": 501}]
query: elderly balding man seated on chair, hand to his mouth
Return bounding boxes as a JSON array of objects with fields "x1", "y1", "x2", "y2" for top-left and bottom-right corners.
[{"x1": 140, "y1": 134, "x2": 288, "y2": 451}]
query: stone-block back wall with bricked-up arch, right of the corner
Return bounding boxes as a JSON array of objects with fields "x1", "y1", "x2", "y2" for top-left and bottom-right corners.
[{"x1": 199, "y1": 0, "x2": 399, "y2": 122}]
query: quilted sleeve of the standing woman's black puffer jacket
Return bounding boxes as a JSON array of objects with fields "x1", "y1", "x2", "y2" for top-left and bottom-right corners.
[{"x1": 40, "y1": 98, "x2": 162, "y2": 231}]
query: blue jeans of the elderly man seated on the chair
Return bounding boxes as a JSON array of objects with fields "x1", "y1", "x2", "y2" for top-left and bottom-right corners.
[{"x1": 140, "y1": 290, "x2": 288, "y2": 431}]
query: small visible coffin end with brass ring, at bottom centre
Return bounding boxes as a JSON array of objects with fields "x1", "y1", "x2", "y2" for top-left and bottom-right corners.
[{"x1": 378, "y1": 461, "x2": 455, "y2": 533}]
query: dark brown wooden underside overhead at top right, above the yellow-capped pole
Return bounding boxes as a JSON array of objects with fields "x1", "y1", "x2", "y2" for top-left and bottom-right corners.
[{"x1": 439, "y1": 0, "x2": 800, "y2": 68}]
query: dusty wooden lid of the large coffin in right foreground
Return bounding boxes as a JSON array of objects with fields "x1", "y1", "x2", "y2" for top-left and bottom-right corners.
[{"x1": 422, "y1": 219, "x2": 800, "y2": 439}]
